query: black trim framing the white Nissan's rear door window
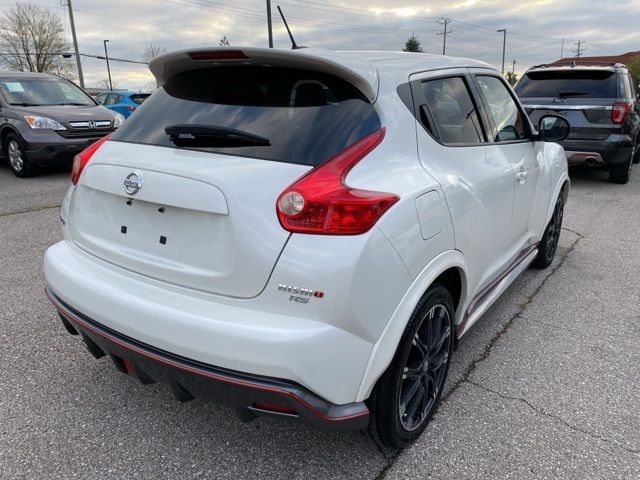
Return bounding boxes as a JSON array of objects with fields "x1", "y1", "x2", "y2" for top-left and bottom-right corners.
[{"x1": 411, "y1": 69, "x2": 491, "y2": 148}]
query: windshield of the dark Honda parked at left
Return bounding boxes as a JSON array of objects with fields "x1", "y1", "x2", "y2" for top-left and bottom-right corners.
[{"x1": 0, "y1": 78, "x2": 95, "y2": 106}]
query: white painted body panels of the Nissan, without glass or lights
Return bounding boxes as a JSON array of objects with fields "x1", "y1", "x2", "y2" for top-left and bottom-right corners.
[{"x1": 44, "y1": 49, "x2": 568, "y2": 405}]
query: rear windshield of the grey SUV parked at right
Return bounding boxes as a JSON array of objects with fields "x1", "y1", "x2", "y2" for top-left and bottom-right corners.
[{"x1": 516, "y1": 70, "x2": 618, "y2": 98}]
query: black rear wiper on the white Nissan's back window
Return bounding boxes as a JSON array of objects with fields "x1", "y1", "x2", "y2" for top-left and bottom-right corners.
[{"x1": 164, "y1": 124, "x2": 271, "y2": 147}]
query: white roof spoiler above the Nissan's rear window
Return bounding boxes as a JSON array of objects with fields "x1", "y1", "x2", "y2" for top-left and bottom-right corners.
[{"x1": 149, "y1": 47, "x2": 378, "y2": 102}]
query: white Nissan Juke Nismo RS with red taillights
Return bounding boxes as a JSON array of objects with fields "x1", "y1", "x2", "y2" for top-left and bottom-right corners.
[{"x1": 44, "y1": 48, "x2": 569, "y2": 448}]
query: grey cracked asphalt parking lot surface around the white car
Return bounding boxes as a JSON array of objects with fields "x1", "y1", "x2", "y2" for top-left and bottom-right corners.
[{"x1": 0, "y1": 165, "x2": 640, "y2": 479}]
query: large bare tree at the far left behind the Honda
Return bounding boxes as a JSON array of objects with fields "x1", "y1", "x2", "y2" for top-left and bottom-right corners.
[{"x1": 0, "y1": 3, "x2": 75, "y2": 78}]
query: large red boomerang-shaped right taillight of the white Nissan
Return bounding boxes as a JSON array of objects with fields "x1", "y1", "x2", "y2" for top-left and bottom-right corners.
[{"x1": 276, "y1": 128, "x2": 400, "y2": 235}]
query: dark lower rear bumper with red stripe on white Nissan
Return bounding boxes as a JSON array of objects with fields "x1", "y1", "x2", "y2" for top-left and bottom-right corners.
[{"x1": 46, "y1": 287, "x2": 369, "y2": 431}]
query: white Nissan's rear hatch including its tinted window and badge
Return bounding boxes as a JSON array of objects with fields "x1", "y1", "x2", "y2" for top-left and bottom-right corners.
[{"x1": 69, "y1": 58, "x2": 380, "y2": 298}]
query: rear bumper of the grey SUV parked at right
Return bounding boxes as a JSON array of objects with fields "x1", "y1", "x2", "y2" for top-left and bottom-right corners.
[{"x1": 560, "y1": 135, "x2": 633, "y2": 164}]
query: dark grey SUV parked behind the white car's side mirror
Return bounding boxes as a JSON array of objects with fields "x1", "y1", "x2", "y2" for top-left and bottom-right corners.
[{"x1": 516, "y1": 64, "x2": 640, "y2": 183}]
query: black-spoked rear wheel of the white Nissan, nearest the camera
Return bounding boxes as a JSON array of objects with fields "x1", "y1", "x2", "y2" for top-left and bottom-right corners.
[{"x1": 369, "y1": 284, "x2": 455, "y2": 449}]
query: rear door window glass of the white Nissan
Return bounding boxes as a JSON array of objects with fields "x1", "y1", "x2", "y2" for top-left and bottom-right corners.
[{"x1": 421, "y1": 77, "x2": 484, "y2": 145}]
